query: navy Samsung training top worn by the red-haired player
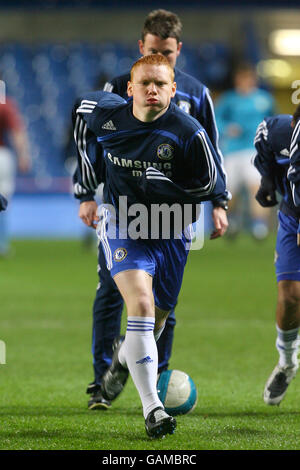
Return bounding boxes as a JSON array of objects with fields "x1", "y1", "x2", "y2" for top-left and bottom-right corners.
[{"x1": 73, "y1": 91, "x2": 226, "y2": 235}]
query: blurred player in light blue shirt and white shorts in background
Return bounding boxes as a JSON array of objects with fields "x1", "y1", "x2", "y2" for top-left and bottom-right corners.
[{"x1": 215, "y1": 64, "x2": 275, "y2": 239}]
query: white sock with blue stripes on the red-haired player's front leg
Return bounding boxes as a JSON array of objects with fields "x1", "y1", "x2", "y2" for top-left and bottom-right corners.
[{"x1": 119, "y1": 317, "x2": 163, "y2": 418}]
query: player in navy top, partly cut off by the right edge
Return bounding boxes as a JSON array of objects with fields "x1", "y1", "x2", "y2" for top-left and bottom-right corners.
[{"x1": 254, "y1": 106, "x2": 300, "y2": 405}]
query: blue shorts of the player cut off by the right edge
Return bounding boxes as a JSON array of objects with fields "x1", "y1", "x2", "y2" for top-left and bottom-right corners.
[{"x1": 275, "y1": 211, "x2": 300, "y2": 282}]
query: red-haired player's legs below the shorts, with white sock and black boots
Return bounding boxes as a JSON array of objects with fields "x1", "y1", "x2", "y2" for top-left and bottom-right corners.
[{"x1": 103, "y1": 270, "x2": 176, "y2": 437}]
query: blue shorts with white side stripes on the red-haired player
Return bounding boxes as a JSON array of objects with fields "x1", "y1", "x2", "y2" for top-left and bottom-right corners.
[{"x1": 97, "y1": 207, "x2": 190, "y2": 311}]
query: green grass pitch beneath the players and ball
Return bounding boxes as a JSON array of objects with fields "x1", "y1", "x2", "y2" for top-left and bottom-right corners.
[{"x1": 0, "y1": 236, "x2": 300, "y2": 450}]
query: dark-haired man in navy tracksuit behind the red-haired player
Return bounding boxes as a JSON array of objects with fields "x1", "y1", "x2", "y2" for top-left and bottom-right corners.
[{"x1": 75, "y1": 9, "x2": 228, "y2": 410}]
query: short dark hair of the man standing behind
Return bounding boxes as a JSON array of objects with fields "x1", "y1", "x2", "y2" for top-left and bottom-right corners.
[{"x1": 142, "y1": 9, "x2": 182, "y2": 42}]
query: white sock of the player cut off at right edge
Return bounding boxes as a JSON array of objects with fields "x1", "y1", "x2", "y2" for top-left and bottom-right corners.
[{"x1": 276, "y1": 325, "x2": 299, "y2": 367}]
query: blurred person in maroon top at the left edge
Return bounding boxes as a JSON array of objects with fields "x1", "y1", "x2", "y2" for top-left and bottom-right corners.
[{"x1": 0, "y1": 88, "x2": 31, "y2": 257}]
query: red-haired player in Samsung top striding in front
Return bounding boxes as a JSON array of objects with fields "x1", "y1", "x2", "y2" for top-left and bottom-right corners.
[{"x1": 73, "y1": 54, "x2": 227, "y2": 437}]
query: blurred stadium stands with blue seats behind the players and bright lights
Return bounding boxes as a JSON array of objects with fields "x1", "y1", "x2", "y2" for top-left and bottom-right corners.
[{"x1": 0, "y1": 0, "x2": 300, "y2": 238}]
